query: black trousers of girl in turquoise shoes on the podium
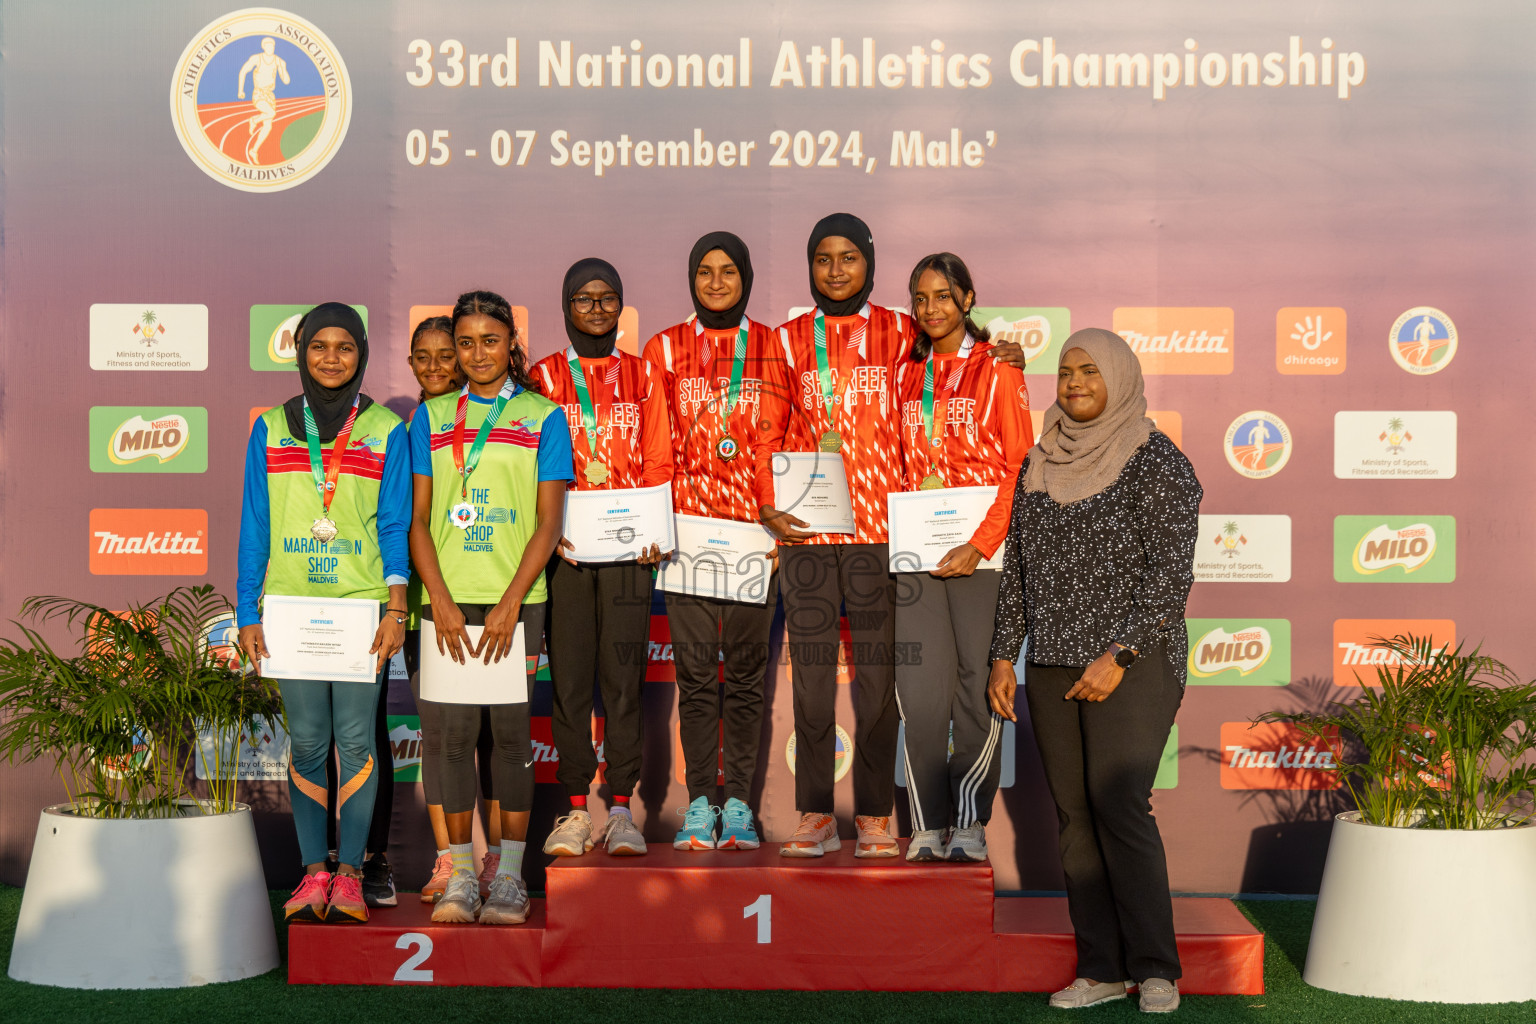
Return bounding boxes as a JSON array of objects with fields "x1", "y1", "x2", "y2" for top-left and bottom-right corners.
[{"x1": 667, "y1": 574, "x2": 779, "y2": 803}]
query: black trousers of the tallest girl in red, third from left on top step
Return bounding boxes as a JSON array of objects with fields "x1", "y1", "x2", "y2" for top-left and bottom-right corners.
[{"x1": 779, "y1": 543, "x2": 900, "y2": 815}]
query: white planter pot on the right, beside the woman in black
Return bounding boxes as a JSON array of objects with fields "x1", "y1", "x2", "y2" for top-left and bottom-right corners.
[{"x1": 1303, "y1": 811, "x2": 1536, "y2": 1003}]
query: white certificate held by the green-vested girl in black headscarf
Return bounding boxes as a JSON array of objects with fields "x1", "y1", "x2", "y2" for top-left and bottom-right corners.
[{"x1": 261, "y1": 594, "x2": 379, "y2": 683}]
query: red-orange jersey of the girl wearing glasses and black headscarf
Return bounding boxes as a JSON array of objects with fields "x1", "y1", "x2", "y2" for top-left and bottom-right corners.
[{"x1": 531, "y1": 348, "x2": 671, "y2": 491}]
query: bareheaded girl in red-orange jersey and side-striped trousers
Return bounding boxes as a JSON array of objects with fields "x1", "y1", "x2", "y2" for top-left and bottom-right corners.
[{"x1": 894, "y1": 252, "x2": 1034, "y2": 861}]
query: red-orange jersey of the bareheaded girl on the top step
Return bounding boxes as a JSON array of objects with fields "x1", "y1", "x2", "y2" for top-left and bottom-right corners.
[{"x1": 894, "y1": 341, "x2": 1034, "y2": 559}]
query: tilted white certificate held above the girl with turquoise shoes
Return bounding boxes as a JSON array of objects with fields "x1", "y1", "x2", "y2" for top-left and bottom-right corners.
[{"x1": 657, "y1": 513, "x2": 774, "y2": 605}]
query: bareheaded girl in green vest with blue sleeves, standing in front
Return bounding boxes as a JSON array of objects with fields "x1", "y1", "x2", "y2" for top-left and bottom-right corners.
[{"x1": 410, "y1": 292, "x2": 571, "y2": 924}]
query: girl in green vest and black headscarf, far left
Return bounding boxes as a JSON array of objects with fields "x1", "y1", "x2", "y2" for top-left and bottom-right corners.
[{"x1": 237, "y1": 302, "x2": 410, "y2": 921}]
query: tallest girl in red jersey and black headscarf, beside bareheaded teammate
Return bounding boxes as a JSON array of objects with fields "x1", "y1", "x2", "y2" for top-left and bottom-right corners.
[{"x1": 760, "y1": 213, "x2": 911, "y2": 857}]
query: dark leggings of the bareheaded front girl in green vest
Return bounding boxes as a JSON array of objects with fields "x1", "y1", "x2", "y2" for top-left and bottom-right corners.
[{"x1": 418, "y1": 602, "x2": 544, "y2": 814}]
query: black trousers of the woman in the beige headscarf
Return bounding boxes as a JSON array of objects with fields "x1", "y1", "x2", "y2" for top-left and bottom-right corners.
[{"x1": 1025, "y1": 648, "x2": 1184, "y2": 983}]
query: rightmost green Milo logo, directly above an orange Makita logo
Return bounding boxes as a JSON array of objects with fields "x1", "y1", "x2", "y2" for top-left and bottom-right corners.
[{"x1": 1333, "y1": 516, "x2": 1456, "y2": 583}]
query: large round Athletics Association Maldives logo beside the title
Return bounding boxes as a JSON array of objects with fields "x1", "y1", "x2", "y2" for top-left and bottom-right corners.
[{"x1": 170, "y1": 8, "x2": 352, "y2": 192}]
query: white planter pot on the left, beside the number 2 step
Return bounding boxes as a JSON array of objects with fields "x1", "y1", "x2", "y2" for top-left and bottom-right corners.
[{"x1": 9, "y1": 804, "x2": 278, "y2": 989}]
